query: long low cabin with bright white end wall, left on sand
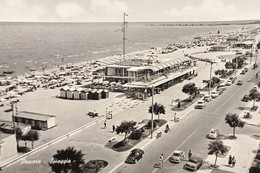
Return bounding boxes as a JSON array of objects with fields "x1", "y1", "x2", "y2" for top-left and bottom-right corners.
[{"x1": 14, "y1": 111, "x2": 56, "y2": 129}]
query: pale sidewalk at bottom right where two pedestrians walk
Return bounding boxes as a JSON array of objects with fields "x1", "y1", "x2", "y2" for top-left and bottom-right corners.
[{"x1": 197, "y1": 135, "x2": 259, "y2": 173}]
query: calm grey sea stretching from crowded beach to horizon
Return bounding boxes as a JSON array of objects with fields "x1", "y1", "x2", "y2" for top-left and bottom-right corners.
[{"x1": 0, "y1": 22, "x2": 252, "y2": 75}]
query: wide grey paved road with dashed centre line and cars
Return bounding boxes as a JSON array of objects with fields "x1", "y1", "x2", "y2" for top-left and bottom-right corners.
[{"x1": 114, "y1": 63, "x2": 259, "y2": 173}]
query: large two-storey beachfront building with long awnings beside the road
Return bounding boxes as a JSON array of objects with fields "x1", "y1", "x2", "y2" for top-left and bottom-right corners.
[{"x1": 102, "y1": 53, "x2": 196, "y2": 98}]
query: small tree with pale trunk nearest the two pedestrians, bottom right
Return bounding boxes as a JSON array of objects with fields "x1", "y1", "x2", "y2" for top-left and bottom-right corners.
[{"x1": 208, "y1": 140, "x2": 227, "y2": 166}]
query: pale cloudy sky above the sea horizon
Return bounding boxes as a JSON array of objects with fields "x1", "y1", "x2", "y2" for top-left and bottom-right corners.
[{"x1": 0, "y1": 0, "x2": 260, "y2": 22}]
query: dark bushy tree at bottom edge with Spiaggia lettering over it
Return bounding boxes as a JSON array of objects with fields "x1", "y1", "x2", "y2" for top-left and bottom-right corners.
[{"x1": 49, "y1": 147, "x2": 85, "y2": 173}]
